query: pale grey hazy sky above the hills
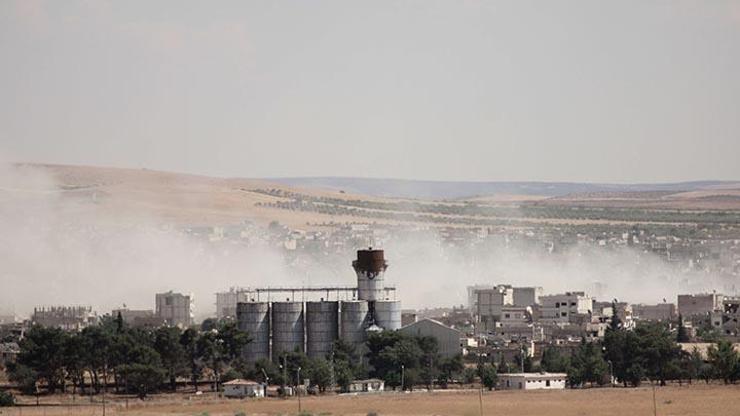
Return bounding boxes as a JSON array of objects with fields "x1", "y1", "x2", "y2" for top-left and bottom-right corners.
[{"x1": 0, "y1": 0, "x2": 740, "y2": 182}]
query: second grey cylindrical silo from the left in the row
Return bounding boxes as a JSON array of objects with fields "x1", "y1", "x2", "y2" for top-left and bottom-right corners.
[{"x1": 272, "y1": 302, "x2": 304, "y2": 359}]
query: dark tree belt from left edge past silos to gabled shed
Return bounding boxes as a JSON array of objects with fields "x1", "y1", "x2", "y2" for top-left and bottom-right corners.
[{"x1": 8, "y1": 316, "x2": 463, "y2": 398}]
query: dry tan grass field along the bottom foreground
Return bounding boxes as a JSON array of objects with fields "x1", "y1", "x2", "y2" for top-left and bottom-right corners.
[{"x1": 0, "y1": 384, "x2": 740, "y2": 416}]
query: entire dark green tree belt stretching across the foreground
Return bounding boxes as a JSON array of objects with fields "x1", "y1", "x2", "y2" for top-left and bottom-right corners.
[{"x1": 2, "y1": 310, "x2": 740, "y2": 404}]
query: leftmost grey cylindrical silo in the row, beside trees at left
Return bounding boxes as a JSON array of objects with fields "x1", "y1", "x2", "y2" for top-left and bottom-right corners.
[{"x1": 236, "y1": 302, "x2": 270, "y2": 362}]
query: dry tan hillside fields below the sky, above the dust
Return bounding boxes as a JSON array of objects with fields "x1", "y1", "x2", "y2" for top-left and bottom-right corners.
[{"x1": 0, "y1": 165, "x2": 740, "y2": 229}]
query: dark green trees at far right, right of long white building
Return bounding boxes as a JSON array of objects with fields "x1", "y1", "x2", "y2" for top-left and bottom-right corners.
[{"x1": 541, "y1": 317, "x2": 740, "y2": 386}]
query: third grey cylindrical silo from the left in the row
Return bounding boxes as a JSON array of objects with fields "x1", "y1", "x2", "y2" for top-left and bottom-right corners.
[{"x1": 306, "y1": 302, "x2": 339, "y2": 358}]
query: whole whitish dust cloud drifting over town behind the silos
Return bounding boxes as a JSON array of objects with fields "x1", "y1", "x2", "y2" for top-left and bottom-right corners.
[{"x1": 0, "y1": 163, "x2": 721, "y2": 316}]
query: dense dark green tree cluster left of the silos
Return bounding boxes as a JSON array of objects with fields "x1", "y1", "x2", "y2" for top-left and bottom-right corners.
[{"x1": 8, "y1": 316, "x2": 249, "y2": 397}]
